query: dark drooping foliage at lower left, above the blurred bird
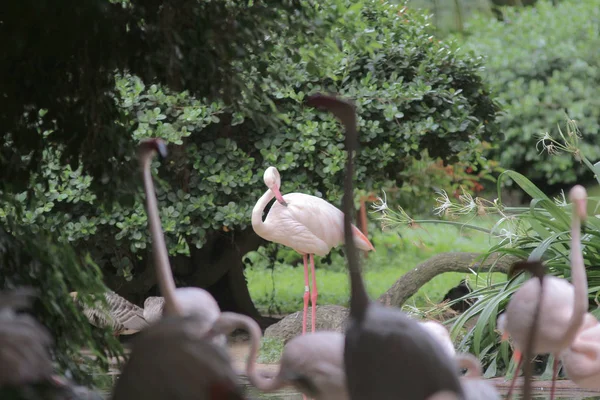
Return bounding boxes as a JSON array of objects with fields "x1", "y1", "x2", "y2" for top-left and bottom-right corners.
[{"x1": 0, "y1": 222, "x2": 122, "y2": 383}]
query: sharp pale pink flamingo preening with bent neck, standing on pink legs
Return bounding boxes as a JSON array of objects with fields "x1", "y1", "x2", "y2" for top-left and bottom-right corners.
[{"x1": 252, "y1": 167, "x2": 375, "y2": 335}]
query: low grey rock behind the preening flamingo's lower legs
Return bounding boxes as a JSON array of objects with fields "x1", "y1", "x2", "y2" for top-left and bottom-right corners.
[{"x1": 265, "y1": 305, "x2": 350, "y2": 343}]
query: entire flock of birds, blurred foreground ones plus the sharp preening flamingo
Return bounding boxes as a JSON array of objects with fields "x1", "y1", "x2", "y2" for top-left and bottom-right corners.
[{"x1": 0, "y1": 94, "x2": 600, "y2": 400}]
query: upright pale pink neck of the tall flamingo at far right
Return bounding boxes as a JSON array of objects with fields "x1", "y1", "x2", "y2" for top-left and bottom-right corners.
[{"x1": 563, "y1": 211, "x2": 589, "y2": 345}]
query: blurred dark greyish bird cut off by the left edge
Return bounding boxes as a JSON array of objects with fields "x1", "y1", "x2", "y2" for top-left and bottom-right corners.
[{"x1": 0, "y1": 288, "x2": 53, "y2": 387}]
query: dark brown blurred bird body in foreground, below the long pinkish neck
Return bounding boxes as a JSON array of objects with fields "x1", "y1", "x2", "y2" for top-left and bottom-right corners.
[{"x1": 111, "y1": 314, "x2": 244, "y2": 400}]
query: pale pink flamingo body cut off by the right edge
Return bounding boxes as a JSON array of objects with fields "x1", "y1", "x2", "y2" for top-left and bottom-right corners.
[{"x1": 560, "y1": 313, "x2": 600, "y2": 390}]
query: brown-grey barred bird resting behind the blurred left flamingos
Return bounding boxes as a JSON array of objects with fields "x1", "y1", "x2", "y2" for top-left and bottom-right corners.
[{"x1": 69, "y1": 291, "x2": 149, "y2": 336}]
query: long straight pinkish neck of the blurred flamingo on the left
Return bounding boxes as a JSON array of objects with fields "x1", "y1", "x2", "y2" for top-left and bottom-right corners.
[{"x1": 140, "y1": 151, "x2": 183, "y2": 315}]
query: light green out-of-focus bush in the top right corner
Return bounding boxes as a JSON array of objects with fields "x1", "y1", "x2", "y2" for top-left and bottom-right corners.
[{"x1": 452, "y1": 0, "x2": 600, "y2": 188}]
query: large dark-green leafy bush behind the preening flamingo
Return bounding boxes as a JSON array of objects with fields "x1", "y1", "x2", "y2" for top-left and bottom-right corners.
[{"x1": 1, "y1": 0, "x2": 497, "y2": 296}]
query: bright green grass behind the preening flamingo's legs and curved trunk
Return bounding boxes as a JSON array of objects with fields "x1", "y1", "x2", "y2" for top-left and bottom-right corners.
[{"x1": 246, "y1": 219, "x2": 506, "y2": 315}]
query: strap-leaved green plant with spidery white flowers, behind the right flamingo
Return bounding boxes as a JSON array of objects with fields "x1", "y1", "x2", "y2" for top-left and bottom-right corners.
[{"x1": 375, "y1": 120, "x2": 600, "y2": 377}]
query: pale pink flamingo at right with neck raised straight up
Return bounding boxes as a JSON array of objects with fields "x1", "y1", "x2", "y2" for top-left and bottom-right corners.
[{"x1": 498, "y1": 185, "x2": 588, "y2": 400}]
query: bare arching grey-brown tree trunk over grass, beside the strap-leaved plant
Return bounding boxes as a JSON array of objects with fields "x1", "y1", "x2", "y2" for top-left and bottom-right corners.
[{"x1": 377, "y1": 253, "x2": 519, "y2": 307}]
